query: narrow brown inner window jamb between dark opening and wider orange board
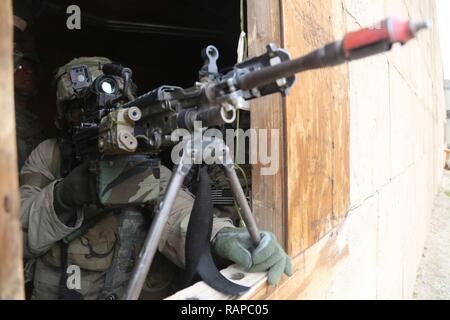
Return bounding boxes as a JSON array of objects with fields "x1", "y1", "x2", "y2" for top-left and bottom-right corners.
[{"x1": 247, "y1": 0, "x2": 286, "y2": 245}]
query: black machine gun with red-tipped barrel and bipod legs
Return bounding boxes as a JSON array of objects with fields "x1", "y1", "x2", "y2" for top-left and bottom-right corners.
[{"x1": 66, "y1": 19, "x2": 428, "y2": 299}]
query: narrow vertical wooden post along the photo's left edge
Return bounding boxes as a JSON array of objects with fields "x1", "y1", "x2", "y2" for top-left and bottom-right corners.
[{"x1": 0, "y1": 0, "x2": 24, "y2": 299}]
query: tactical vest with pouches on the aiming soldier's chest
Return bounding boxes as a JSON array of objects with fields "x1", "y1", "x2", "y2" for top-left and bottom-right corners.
[{"x1": 42, "y1": 205, "x2": 155, "y2": 300}]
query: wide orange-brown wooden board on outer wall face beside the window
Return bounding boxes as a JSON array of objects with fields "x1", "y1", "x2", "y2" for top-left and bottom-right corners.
[{"x1": 282, "y1": 0, "x2": 349, "y2": 256}]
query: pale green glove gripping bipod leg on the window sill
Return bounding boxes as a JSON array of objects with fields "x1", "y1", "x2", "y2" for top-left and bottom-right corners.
[{"x1": 213, "y1": 228, "x2": 292, "y2": 286}]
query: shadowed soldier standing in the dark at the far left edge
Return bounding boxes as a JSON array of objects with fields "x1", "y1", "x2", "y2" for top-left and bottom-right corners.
[{"x1": 13, "y1": 1, "x2": 44, "y2": 169}]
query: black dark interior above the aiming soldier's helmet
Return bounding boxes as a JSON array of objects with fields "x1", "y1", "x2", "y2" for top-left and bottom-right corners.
[{"x1": 31, "y1": 0, "x2": 240, "y2": 137}]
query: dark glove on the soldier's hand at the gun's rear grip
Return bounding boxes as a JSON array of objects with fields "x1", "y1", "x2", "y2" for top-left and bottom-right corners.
[{"x1": 53, "y1": 162, "x2": 91, "y2": 215}]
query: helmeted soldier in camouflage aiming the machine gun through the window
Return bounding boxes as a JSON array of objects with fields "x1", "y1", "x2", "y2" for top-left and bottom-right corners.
[{"x1": 20, "y1": 58, "x2": 291, "y2": 299}]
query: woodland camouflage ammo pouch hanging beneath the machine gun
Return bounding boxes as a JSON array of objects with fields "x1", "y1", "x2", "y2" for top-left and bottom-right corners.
[{"x1": 97, "y1": 155, "x2": 160, "y2": 207}]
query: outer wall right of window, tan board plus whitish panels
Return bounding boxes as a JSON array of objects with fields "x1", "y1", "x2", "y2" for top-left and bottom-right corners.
[{"x1": 249, "y1": 0, "x2": 445, "y2": 299}]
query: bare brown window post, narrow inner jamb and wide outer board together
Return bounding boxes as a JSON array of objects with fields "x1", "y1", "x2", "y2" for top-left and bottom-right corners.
[{"x1": 247, "y1": 0, "x2": 349, "y2": 256}]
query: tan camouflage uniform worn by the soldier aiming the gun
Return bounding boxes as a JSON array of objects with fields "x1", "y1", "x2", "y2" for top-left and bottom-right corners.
[{"x1": 20, "y1": 139, "x2": 232, "y2": 299}]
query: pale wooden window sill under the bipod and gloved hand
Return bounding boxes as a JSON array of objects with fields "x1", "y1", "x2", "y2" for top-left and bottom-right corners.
[{"x1": 167, "y1": 229, "x2": 349, "y2": 300}]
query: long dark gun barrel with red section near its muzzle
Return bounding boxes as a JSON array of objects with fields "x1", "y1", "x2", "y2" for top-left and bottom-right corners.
[{"x1": 236, "y1": 18, "x2": 430, "y2": 90}]
